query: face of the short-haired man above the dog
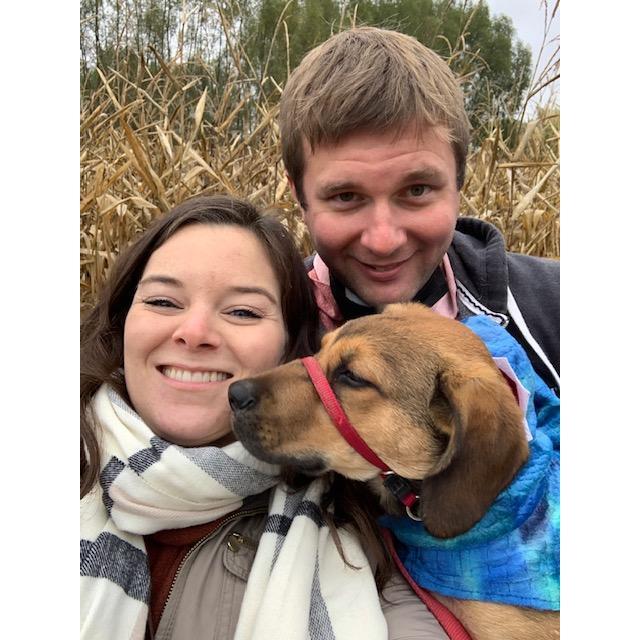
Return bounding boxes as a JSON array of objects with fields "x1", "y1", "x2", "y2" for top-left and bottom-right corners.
[{"x1": 302, "y1": 128, "x2": 459, "y2": 308}]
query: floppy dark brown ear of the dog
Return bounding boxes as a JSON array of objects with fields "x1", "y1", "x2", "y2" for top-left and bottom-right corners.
[{"x1": 420, "y1": 367, "x2": 528, "y2": 538}]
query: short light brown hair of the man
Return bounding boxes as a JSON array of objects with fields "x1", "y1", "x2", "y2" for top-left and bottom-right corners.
[{"x1": 280, "y1": 27, "x2": 469, "y2": 206}]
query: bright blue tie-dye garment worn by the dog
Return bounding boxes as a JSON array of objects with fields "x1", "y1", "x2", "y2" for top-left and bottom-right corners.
[{"x1": 381, "y1": 316, "x2": 560, "y2": 611}]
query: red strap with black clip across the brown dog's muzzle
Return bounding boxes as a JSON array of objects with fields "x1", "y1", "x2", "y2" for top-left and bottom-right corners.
[{"x1": 301, "y1": 356, "x2": 420, "y2": 520}]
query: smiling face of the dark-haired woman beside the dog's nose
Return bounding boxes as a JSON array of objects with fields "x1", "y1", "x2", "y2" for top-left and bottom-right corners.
[{"x1": 124, "y1": 224, "x2": 287, "y2": 446}]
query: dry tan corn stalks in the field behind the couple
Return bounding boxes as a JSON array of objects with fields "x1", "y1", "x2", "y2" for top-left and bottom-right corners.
[{"x1": 80, "y1": 18, "x2": 560, "y2": 308}]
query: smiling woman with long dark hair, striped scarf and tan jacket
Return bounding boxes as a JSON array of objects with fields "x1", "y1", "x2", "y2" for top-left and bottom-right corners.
[{"x1": 81, "y1": 197, "x2": 444, "y2": 639}]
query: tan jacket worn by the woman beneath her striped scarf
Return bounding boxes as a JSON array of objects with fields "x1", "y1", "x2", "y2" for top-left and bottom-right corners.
[{"x1": 149, "y1": 498, "x2": 447, "y2": 640}]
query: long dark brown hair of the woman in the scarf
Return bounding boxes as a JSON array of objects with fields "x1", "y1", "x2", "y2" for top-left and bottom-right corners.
[{"x1": 80, "y1": 196, "x2": 391, "y2": 586}]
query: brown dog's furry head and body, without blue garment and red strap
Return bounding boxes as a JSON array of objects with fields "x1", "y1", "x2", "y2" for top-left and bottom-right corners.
[{"x1": 229, "y1": 303, "x2": 559, "y2": 640}]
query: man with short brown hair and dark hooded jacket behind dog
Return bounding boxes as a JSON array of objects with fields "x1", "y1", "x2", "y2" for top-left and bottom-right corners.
[{"x1": 280, "y1": 27, "x2": 560, "y2": 393}]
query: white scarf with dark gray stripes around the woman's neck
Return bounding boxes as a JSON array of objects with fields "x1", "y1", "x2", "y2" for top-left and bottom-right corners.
[{"x1": 80, "y1": 385, "x2": 387, "y2": 640}]
